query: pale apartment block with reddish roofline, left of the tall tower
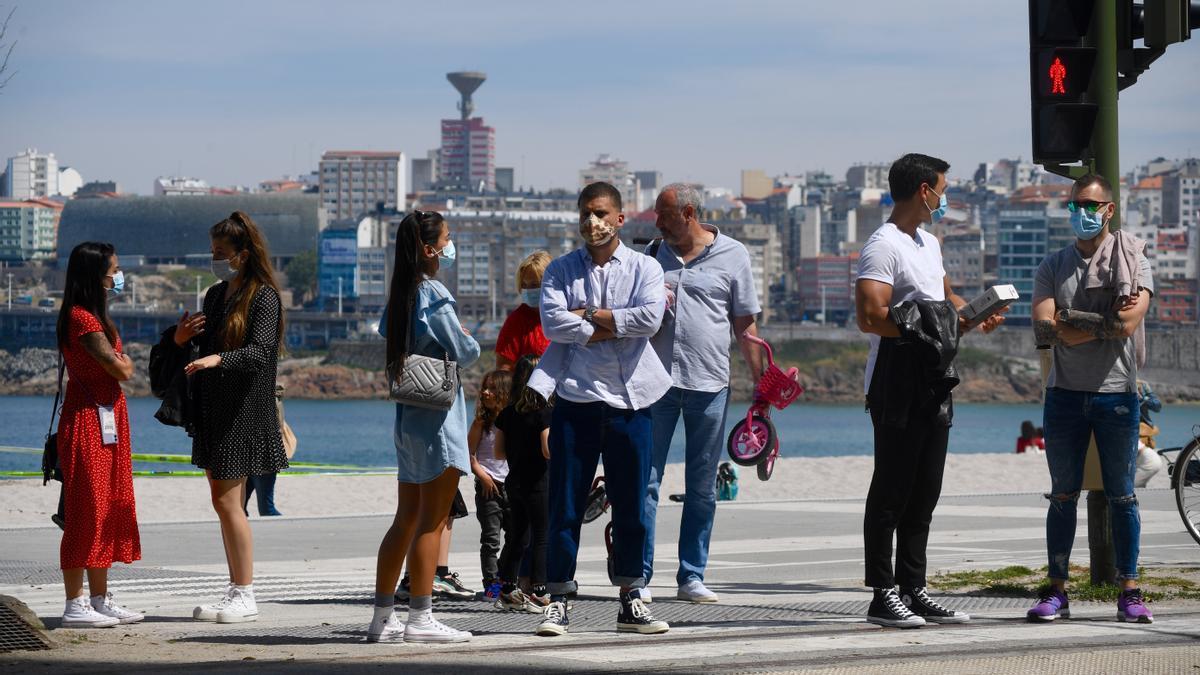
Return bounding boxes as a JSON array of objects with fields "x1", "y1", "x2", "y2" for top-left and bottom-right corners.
[{"x1": 319, "y1": 150, "x2": 408, "y2": 228}]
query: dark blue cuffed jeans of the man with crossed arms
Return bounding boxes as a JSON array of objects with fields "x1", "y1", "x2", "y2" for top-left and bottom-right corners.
[{"x1": 546, "y1": 398, "x2": 650, "y2": 595}]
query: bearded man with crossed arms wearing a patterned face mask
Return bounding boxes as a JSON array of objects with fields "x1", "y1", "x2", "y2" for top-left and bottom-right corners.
[{"x1": 529, "y1": 183, "x2": 671, "y2": 635}]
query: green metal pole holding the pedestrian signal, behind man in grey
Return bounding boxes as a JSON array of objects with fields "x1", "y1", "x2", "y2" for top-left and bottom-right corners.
[{"x1": 1087, "y1": 0, "x2": 1121, "y2": 586}]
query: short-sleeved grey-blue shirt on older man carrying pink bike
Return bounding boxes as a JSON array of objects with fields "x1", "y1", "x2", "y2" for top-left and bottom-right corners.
[{"x1": 647, "y1": 225, "x2": 762, "y2": 392}]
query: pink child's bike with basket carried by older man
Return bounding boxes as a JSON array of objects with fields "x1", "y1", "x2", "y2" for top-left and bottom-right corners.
[{"x1": 727, "y1": 334, "x2": 804, "y2": 480}]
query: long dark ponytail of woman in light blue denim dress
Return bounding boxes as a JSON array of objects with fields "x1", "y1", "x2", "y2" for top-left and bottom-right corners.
[{"x1": 386, "y1": 210, "x2": 445, "y2": 380}]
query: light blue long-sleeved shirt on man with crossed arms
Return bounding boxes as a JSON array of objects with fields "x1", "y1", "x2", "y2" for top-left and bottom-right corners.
[{"x1": 529, "y1": 244, "x2": 671, "y2": 410}]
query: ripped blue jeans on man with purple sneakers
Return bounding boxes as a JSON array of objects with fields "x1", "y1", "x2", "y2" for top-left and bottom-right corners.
[{"x1": 1043, "y1": 388, "x2": 1141, "y2": 580}]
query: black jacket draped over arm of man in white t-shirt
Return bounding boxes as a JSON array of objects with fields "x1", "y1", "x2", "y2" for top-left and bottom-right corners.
[{"x1": 866, "y1": 300, "x2": 959, "y2": 429}]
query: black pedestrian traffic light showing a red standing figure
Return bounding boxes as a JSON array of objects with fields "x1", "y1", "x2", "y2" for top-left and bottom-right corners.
[{"x1": 1030, "y1": 0, "x2": 1099, "y2": 163}]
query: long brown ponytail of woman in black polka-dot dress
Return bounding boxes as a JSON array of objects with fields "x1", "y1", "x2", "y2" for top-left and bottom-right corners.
[{"x1": 209, "y1": 211, "x2": 284, "y2": 353}]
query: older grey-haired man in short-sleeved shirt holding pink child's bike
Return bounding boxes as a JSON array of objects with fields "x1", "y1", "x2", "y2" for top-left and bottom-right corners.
[{"x1": 643, "y1": 183, "x2": 762, "y2": 602}]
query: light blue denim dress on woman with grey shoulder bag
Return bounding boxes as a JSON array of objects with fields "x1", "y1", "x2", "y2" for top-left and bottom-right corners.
[{"x1": 379, "y1": 279, "x2": 479, "y2": 483}]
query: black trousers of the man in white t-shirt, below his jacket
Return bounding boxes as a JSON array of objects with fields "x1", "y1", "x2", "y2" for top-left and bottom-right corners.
[{"x1": 863, "y1": 401, "x2": 950, "y2": 589}]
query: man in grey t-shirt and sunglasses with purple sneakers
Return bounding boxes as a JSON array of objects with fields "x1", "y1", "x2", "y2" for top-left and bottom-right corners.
[{"x1": 1026, "y1": 174, "x2": 1154, "y2": 623}]
